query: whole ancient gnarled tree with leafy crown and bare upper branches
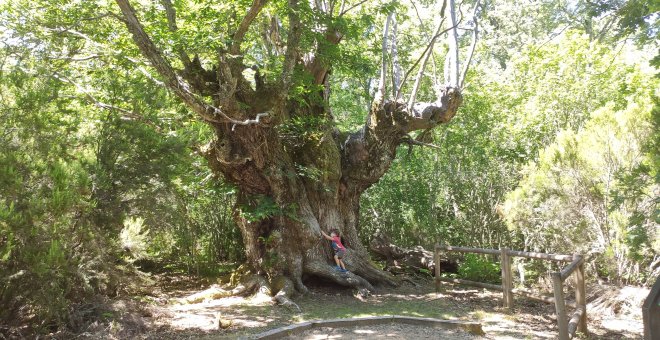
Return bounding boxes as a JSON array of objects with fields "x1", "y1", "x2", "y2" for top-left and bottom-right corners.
[{"x1": 116, "y1": 0, "x2": 479, "y2": 300}]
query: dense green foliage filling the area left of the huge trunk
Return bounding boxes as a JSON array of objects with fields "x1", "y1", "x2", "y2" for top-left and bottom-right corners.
[{"x1": 0, "y1": 1, "x2": 243, "y2": 332}]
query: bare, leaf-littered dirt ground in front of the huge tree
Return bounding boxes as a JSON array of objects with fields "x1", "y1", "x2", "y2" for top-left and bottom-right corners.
[{"x1": 71, "y1": 278, "x2": 648, "y2": 339}]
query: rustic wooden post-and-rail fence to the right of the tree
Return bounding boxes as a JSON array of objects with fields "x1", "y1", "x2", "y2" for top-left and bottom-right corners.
[{"x1": 434, "y1": 245, "x2": 587, "y2": 340}]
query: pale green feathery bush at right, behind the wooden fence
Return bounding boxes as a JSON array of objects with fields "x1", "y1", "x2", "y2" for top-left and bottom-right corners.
[{"x1": 505, "y1": 92, "x2": 660, "y2": 283}]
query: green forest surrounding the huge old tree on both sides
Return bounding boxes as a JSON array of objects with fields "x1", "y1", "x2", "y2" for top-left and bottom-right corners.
[{"x1": 0, "y1": 0, "x2": 660, "y2": 329}]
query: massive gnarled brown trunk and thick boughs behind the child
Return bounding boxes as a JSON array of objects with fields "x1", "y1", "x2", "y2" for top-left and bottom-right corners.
[{"x1": 117, "y1": 0, "x2": 470, "y2": 300}]
